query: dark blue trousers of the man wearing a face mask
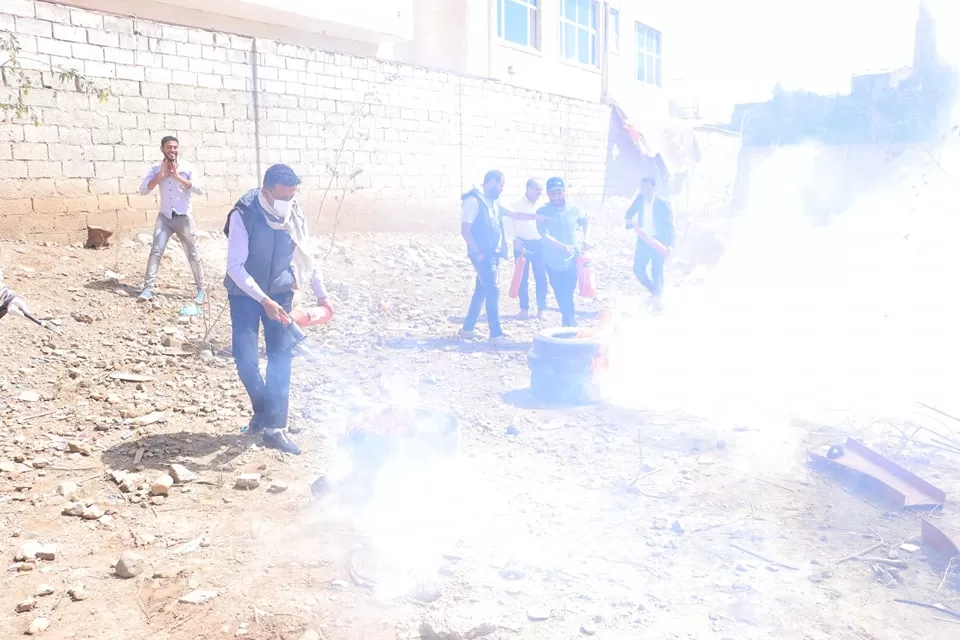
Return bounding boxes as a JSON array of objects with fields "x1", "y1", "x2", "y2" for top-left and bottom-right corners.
[{"x1": 229, "y1": 292, "x2": 294, "y2": 429}]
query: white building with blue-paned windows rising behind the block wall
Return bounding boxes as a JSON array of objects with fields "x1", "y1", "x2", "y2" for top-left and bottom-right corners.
[{"x1": 54, "y1": 0, "x2": 669, "y2": 114}]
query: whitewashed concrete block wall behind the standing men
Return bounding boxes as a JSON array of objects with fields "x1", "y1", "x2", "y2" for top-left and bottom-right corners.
[{"x1": 0, "y1": 0, "x2": 610, "y2": 239}]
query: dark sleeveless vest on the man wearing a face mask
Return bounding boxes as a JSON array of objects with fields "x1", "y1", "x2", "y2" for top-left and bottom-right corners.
[{"x1": 223, "y1": 189, "x2": 297, "y2": 296}]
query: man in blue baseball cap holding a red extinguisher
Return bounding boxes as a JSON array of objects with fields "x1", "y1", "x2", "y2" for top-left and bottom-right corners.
[{"x1": 537, "y1": 177, "x2": 588, "y2": 327}]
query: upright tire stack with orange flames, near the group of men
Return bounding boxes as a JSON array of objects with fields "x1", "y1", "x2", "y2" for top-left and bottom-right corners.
[{"x1": 527, "y1": 328, "x2": 606, "y2": 404}]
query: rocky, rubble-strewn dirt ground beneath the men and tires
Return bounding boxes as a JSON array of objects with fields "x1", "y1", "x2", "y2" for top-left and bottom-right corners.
[{"x1": 0, "y1": 226, "x2": 960, "y2": 640}]
